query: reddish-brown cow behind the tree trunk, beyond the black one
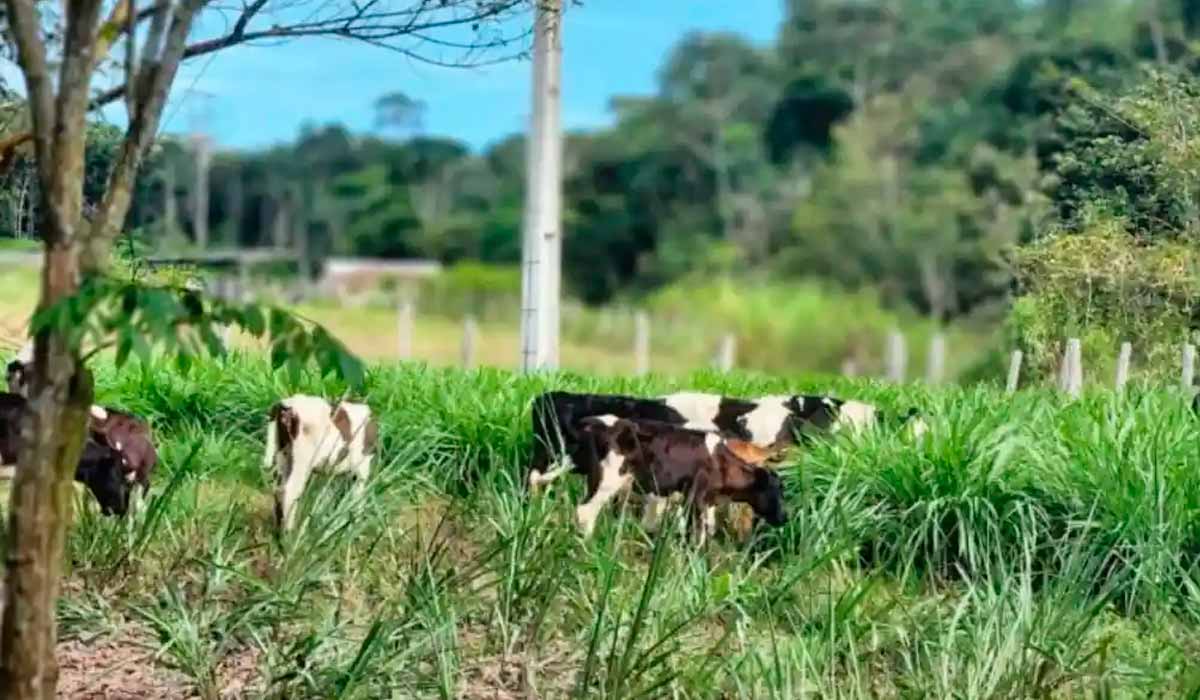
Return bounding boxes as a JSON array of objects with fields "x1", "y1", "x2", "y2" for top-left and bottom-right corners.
[{"x1": 6, "y1": 342, "x2": 158, "y2": 496}]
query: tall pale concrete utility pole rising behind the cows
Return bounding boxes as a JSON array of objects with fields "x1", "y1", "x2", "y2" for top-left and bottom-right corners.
[{"x1": 521, "y1": 0, "x2": 563, "y2": 372}]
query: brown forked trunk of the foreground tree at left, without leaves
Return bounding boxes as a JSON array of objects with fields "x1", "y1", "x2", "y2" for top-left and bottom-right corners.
[{"x1": 0, "y1": 0, "x2": 202, "y2": 700}]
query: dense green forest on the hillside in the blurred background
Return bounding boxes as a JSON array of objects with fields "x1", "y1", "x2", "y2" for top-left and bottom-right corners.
[{"x1": 0, "y1": 0, "x2": 1200, "y2": 374}]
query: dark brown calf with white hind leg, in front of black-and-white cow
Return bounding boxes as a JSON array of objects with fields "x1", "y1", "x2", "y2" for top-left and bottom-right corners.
[{"x1": 576, "y1": 414, "x2": 787, "y2": 544}]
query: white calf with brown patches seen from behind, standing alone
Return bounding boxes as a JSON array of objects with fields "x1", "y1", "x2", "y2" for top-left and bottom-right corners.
[{"x1": 263, "y1": 394, "x2": 379, "y2": 530}]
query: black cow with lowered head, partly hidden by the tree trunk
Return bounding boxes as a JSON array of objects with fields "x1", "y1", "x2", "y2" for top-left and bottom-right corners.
[{"x1": 0, "y1": 393, "x2": 133, "y2": 515}]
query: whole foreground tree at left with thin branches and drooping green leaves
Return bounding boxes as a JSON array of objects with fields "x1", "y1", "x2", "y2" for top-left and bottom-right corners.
[{"x1": 0, "y1": 0, "x2": 526, "y2": 700}]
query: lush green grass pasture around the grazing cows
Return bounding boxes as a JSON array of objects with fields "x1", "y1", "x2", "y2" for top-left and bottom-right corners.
[{"x1": 7, "y1": 355, "x2": 1200, "y2": 699}]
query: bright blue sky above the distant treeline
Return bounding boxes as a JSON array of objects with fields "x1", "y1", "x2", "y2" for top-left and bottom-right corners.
[{"x1": 138, "y1": 0, "x2": 782, "y2": 149}]
